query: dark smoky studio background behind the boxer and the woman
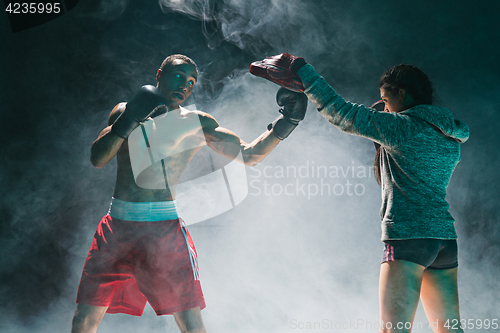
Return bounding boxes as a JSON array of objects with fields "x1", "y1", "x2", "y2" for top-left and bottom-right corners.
[{"x1": 0, "y1": 0, "x2": 500, "y2": 332}]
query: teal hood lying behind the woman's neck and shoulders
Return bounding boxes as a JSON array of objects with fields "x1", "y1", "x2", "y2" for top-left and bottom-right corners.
[{"x1": 399, "y1": 105, "x2": 469, "y2": 143}]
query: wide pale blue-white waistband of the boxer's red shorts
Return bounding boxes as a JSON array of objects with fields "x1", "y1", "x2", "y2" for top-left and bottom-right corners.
[{"x1": 108, "y1": 198, "x2": 179, "y2": 222}]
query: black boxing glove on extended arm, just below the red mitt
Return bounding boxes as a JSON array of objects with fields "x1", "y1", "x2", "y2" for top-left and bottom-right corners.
[{"x1": 267, "y1": 88, "x2": 307, "y2": 140}]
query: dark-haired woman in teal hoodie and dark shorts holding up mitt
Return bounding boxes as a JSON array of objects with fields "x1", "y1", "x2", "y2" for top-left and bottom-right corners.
[{"x1": 266, "y1": 55, "x2": 469, "y2": 332}]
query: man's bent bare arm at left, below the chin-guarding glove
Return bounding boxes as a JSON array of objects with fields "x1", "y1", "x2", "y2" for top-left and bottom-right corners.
[{"x1": 90, "y1": 103, "x2": 126, "y2": 169}]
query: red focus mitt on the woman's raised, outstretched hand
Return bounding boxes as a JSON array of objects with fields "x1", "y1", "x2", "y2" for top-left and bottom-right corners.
[{"x1": 250, "y1": 53, "x2": 305, "y2": 92}]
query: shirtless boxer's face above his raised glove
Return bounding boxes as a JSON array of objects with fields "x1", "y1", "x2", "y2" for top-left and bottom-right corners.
[{"x1": 157, "y1": 59, "x2": 198, "y2": 110}]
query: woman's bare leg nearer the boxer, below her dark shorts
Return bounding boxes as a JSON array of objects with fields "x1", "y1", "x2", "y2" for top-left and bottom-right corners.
[{"x1": 379, "y1": 260, "x2": 424, "y2": 333}]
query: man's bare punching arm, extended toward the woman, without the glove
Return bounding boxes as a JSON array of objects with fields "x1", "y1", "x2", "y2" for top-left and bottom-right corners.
[{"x1": 200, "y1": 114, "x2": 280, "y2": 166}]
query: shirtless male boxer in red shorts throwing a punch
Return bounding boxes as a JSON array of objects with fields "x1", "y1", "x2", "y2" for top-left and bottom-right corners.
[{"x1": 72, "y1": 55, "x2": 307, "y2": 333}]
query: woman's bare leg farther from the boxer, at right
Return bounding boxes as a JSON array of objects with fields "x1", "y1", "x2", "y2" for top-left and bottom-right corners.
[{"x1": 420, "y1": 268, "x2": 463, "y2": 333}]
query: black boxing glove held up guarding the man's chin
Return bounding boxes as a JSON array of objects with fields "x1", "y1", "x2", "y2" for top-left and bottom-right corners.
[{"x1": 111, "y1": 85, "x2": 167, "y2": 139}]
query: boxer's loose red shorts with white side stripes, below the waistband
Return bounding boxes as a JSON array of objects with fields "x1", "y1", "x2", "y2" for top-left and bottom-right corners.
[{"x1": 76, "y1": 200, "x2": 205, "y2": 316}]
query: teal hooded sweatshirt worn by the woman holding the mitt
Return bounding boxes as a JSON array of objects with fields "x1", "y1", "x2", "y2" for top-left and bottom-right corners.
[{"x1": 297, "y1": 64, "x2": 469, "y2": 241}]
